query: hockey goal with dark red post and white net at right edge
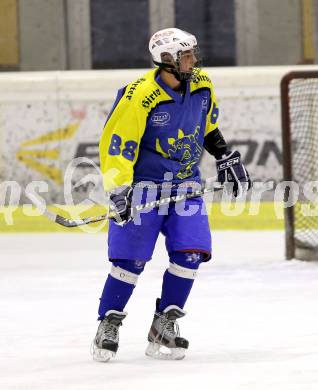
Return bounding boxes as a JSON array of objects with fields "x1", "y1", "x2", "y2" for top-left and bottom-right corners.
[{"x1": 281, "y1": 71, "x2": 318, "y2": 260}]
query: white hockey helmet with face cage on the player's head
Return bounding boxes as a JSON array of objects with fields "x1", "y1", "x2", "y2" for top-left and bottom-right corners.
[{"x1": 149, "y1": 28, "x2": 198, "y2": 80}]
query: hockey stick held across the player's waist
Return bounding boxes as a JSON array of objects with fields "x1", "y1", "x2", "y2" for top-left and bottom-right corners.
[{"x1": 36, "y1": 184, "x2": 223, "y2": 227}]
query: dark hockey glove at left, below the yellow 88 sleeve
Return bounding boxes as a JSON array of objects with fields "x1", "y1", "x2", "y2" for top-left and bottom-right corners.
[{"x1": 109, "y1": 186, "x2": 133, "y2": 226}]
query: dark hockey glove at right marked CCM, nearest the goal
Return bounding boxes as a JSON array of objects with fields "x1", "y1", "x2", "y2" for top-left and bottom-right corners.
[{"x1": 216, "y1": 150, "x2": 251, "y2": 197}]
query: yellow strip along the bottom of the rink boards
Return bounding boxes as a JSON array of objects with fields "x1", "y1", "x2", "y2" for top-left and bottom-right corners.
[{"x1": 0, "y1": 202, "x2": 284, "y2": 233}]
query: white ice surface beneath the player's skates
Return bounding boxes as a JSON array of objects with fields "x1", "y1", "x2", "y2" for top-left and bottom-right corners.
[{"x1": 0, "y1": 231, "x2": 318, "y2": 390}]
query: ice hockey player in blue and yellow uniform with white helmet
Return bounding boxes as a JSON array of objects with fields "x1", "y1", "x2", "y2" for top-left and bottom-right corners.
[{"x1": 92, "y1": 28, "x2": 250, "y2": 362}]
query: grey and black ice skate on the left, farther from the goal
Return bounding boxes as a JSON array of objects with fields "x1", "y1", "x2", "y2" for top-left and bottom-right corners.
[{"x1": 91, "y1": 310, "x2": 127, "y2": 362}]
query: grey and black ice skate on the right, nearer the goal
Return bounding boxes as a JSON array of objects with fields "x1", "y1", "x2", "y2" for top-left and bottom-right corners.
[{"x1": 146, "y1": 300, "x2": 189, "y2": 360}]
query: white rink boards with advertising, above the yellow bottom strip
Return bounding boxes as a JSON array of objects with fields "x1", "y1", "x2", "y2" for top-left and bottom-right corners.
[{"x1": 0, "y1": 66, "x2": 318, "y2": 203}]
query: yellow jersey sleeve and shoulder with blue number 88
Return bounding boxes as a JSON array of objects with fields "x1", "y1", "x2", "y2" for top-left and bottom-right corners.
[{"x1": 99, "y1": 69, "x2": 172, "y2": 191}]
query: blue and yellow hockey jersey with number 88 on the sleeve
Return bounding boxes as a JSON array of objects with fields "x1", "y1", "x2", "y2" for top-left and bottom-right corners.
[{"x1": 99, "y1": 69, "x2": 218, "y2": 191}]
